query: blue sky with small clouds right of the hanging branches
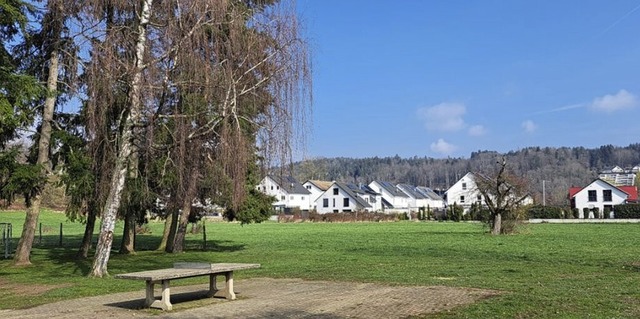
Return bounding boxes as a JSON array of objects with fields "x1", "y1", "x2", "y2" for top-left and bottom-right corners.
[{"x1": 297, "y1": 0, "x2": 640, "y2": 158}]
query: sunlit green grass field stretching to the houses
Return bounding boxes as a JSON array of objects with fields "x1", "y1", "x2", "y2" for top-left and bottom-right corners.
[{"x1": 0, "y1": 211, "x2": 640, "y2": 318}]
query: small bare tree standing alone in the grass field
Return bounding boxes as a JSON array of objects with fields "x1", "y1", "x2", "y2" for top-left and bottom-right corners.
[{"x1": 475, "y1": 157, "x2": 529, "y2": 235}]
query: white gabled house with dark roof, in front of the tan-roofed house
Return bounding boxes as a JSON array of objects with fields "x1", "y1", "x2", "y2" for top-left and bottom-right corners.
[{"x1": 315, "y1": 182, "x2": 373, "y2": 214}]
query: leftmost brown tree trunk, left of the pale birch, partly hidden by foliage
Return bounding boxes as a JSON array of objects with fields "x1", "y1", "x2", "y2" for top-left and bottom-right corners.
[{"x1": 14, "y1": 45, "x2": 59, "y2": 265}]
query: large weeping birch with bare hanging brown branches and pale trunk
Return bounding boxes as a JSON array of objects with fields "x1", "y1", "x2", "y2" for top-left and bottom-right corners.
[{"x1": 74, "y1": 0, "x2": 311, "y2": 277}]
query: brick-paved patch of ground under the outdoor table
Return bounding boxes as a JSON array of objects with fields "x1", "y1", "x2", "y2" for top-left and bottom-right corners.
[{"x1": 0, "y1": 278, "x2": 498, "y2": 319}]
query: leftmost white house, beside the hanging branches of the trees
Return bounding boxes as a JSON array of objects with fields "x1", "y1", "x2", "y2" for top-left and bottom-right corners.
[{"x1": 256, "y1": 175, "x2": 311, "y2": 213}]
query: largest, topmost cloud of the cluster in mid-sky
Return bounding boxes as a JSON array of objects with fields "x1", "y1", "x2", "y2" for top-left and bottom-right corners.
[{"x1": 417, "y1": 103, "x2": 467, "y2": 132}]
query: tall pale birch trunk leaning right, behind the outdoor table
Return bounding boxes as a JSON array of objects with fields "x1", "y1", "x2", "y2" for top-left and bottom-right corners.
[{"x1": 90, "y1": 0, "x2": 152, "y2": 277}]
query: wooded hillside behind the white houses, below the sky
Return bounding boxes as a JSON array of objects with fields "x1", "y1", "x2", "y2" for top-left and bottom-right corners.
[{"x1": 293, "y1": 143, "x2": 640, "y2": 205}]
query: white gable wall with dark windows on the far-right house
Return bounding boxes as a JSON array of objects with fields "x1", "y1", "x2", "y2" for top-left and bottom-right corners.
[{"x1": 573, "y1": 179, "x2": 628, "y2": 218}]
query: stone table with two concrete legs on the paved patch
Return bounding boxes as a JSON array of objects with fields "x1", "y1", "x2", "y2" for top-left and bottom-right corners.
[{"x1": 115, "y1": 263, "x2": 260, "y2": 310}]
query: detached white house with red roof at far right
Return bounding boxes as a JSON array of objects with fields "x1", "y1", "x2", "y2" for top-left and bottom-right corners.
[{"x1": 569, "y1": 178, "x2": 638, "y2": 218}]
